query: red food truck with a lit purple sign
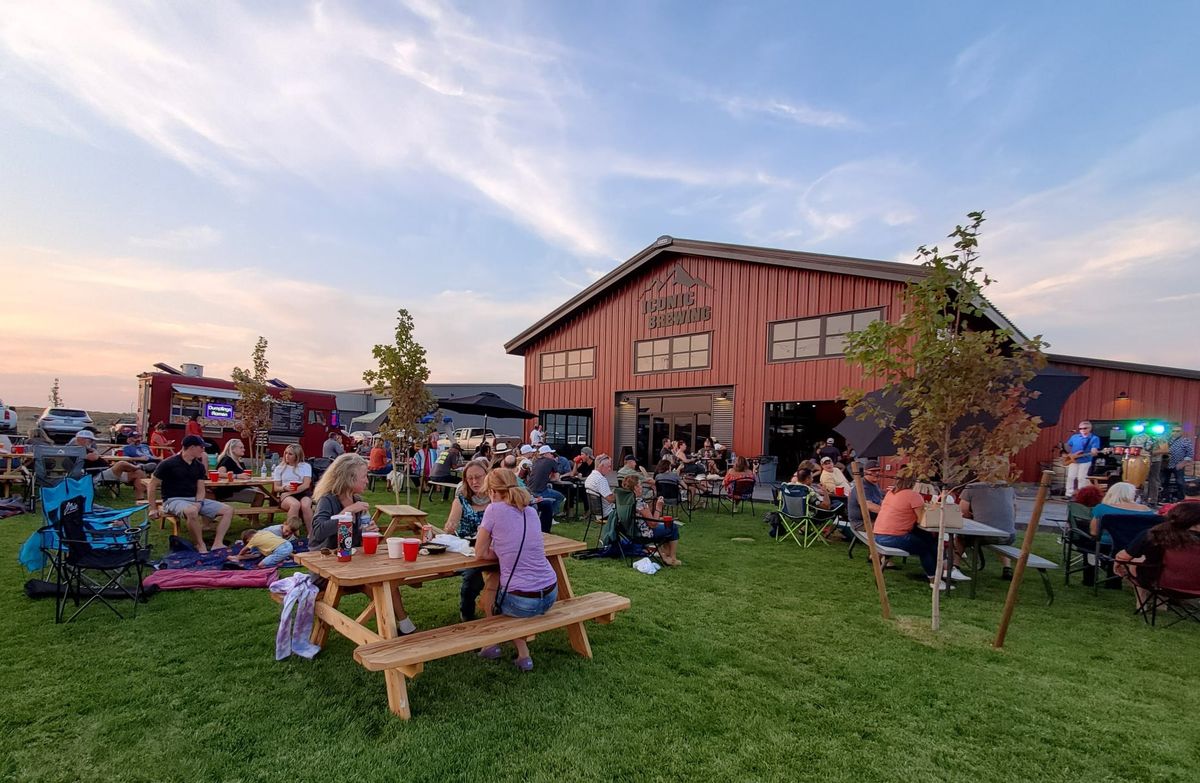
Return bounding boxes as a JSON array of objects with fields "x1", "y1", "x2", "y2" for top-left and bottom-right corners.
[{"x1": 138, "y1": 365, "x2": 337, "y2": 456}]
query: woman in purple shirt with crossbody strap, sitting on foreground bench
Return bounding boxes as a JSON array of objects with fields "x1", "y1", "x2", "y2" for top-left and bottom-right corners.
[{"x1": 475, "y1": 468, "x2": 558, "y2": 671}]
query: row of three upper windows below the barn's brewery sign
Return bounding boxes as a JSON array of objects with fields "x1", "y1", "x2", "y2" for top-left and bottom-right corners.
[{"x1": 539, "y1": 309, "x2": 883, "y2": 381}]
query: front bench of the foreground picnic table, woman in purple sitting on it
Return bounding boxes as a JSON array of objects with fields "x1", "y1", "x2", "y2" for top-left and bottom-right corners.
[{"x1": 354, "y1": 592, "x2": 630, "y2": 721}]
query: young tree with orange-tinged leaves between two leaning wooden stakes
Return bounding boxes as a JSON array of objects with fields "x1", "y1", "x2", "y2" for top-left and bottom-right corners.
[{"x1": 845, "y1": 213, "x2": 1045, "y2": 629}]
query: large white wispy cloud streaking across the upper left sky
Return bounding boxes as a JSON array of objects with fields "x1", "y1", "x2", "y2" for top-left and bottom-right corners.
[{"x1": 0, "y1": 0, "x2": 612, "y2": 256}]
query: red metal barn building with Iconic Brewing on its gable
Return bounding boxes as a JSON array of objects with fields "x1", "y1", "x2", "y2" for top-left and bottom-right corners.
[{"x1": 505, "y1": 237, "x2": 1200, "y2": 479}]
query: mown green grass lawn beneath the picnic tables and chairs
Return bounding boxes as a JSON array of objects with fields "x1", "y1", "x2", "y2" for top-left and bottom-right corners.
[{"x1": 0, "y1": 492, "x2": 1200, "y2": 782}]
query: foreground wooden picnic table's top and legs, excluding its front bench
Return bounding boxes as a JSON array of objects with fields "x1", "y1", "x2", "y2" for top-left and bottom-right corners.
[{"x1": 294, "y1": 533, "x2": 592, "y2": 718}]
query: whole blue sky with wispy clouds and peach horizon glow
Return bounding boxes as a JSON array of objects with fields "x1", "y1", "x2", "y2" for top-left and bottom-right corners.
[{"x1": 0, "y1": 0, "x2": 1200, "y2": 411}]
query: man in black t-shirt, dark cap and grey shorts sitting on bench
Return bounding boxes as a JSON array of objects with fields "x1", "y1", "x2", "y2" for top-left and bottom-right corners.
[{"x1": 146, "y1": 435, "x2": 233, "y2": 554}]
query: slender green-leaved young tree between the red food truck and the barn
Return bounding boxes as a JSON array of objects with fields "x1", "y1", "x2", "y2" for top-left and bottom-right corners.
[{"x1": 362, "y1": 309, "x2": 437, "y2": 503}]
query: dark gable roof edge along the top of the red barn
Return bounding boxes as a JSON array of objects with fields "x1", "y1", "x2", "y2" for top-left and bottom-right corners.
[{"x1": 504, "y1": 235, "x2": 1026, "y2": 355}]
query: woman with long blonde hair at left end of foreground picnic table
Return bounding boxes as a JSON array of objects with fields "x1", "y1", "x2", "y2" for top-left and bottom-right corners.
[{"x1": 308, "y1": 454, "x2": 416, "y2": 635}]
